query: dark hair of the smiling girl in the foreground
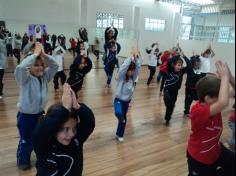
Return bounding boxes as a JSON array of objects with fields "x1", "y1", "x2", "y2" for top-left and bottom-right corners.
[{"x1": 46, "y1": 103, "x2": 78, "y2": 132}]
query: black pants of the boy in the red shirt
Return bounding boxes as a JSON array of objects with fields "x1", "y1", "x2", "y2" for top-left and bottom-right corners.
[{"x1": 187, "y1": 145, "x2": 235, "y2": 176}]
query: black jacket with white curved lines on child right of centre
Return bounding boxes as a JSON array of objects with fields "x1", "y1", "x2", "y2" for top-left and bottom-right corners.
[{"x1": 164, "y1": 56, "x2": 188, "y2": 92}]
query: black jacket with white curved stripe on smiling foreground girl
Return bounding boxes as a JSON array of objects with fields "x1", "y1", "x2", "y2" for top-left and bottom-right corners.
[{"x1": 33, "y1": 104, "x2": 95, "y2": 176}]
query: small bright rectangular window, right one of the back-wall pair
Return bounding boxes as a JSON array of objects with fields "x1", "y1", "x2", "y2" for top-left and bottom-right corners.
[{"x1": 145, "y1": 18, "x2": 166, "y2": 32}]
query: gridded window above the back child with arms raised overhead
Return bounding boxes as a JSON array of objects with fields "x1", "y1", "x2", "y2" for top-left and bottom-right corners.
[{"x1": 97, "y1": 12, "x2": 124, "y2": 29}]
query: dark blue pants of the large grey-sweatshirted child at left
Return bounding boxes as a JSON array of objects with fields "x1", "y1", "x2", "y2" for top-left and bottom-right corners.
[{"x1": 16, "y1": 112, "x2": 43, "y2": 165}]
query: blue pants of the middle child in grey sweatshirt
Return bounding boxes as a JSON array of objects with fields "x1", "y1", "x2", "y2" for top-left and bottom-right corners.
[{"x1": 114, "y1": 98, "x2": 130, "y2": 137}]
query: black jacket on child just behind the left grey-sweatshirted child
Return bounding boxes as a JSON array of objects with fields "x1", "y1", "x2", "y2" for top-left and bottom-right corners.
[{"x1": 67, "y1": 56, "x2": 93, "y2": 93}]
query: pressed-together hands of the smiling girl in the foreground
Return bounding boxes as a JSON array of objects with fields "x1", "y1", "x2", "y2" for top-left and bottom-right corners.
[{"x1": 62, "y1": 83, "x2": 73, "y2": 110}]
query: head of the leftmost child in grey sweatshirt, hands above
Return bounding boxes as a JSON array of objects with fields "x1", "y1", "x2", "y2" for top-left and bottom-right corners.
[{"x1": 30, "y1": 56, "x2": 45, "y2": 78}]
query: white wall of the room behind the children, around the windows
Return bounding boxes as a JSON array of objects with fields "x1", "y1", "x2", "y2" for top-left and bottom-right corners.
[{"x1": 0, "y1": 0, "x2": 235, "y2": 70}]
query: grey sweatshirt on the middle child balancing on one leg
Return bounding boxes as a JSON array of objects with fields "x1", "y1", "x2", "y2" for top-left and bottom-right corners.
[{"x1": 116, "y1": 58, "x2": 142, "y2": 101}]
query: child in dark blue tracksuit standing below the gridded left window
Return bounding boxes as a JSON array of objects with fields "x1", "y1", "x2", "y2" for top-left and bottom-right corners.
[{"x1": 104, "y1": 42, "x2": 121, "y2": 88}]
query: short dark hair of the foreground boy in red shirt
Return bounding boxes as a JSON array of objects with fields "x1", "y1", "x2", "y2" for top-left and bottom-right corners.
[{"x1": 196, "y1": 76, "x2": 221, "y2": 102}]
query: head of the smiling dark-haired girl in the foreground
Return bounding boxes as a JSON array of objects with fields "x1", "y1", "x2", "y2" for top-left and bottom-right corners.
[{"x1": 46, "y1": 103, "x2": 79, "y2": 146}]
